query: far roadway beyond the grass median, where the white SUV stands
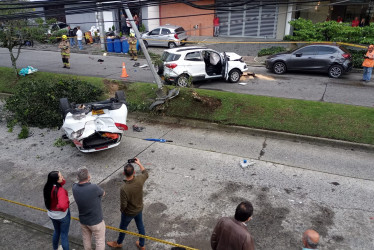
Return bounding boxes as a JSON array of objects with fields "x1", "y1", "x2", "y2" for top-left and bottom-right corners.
[{"x1": 0, "y1": 48, "x2": 374, "y2": 107}]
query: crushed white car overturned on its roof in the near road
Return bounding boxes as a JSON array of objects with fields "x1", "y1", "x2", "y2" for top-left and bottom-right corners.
[{"x1": 60, "y1": 91, "x2": 128, "y2": 153}]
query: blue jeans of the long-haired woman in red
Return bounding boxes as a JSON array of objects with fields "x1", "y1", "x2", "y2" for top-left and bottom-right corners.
[{"x1": 51, "y1": 209, "x2": 70, "y2": 250}]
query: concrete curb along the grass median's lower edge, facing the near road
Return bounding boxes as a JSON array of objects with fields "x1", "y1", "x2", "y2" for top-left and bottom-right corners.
[{"x1": 128, "y1": 112, "x2": 374, "y2": 152}]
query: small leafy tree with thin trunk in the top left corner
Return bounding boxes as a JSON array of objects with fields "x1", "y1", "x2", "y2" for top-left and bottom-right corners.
[{"x1": 0, "y1": 1, "x2": 48, "y2": 76}]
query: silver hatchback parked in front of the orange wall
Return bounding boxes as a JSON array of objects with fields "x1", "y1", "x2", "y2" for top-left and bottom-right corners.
[{"x1": 142, "y1": 25, "x2": 188, "y2": 48}]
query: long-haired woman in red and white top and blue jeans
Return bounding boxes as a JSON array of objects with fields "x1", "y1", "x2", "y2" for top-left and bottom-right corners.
[{"x1": 43, "y1": 171, "x2": 70, "y2": 250}]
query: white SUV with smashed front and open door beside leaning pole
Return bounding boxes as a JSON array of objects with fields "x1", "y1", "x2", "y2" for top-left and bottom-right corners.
[{"x1": 156, "y1": 47, "x2": 248, "y2": 87}]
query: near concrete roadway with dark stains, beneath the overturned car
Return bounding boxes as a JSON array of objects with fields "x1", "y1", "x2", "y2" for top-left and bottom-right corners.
[{"x1": 0, "y1": 112, "x2": 374, "y2": 250}]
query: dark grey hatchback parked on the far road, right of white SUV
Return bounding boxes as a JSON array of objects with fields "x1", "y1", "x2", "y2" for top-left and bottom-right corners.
[{"x1": 266, "y1": 44, "x2": 352, "y2": 78}]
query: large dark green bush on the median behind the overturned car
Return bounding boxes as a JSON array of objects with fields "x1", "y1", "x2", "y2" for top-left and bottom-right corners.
[{"x1": 5, "y1": 79, "x2": 103, "y2": 128}]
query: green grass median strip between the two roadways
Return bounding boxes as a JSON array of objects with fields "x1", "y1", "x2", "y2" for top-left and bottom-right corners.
[{"x1": 0, "y1": 68, "x2": 374, "y2": 144}]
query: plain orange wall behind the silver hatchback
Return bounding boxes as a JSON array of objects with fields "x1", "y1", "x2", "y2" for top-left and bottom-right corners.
[{"x1": 160, "y1": 0, "x2": 214, "y2": 36}]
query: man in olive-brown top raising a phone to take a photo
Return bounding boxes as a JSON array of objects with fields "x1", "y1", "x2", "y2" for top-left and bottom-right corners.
[{"x1": 107, "y1": 158, "x2": 148, "y2": 250}]
